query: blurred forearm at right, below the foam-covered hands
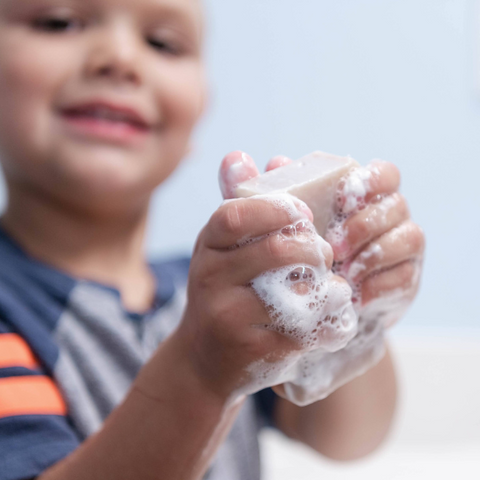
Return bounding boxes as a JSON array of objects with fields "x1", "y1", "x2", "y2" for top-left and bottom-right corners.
[{"x1": 276, "y1": 348, "x2": 397, "y2": 460}]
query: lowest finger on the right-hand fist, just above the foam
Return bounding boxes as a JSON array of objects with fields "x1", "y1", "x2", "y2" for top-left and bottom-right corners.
[{"x1": 361, "y1": 260, "x2": 420, "y2": 305}]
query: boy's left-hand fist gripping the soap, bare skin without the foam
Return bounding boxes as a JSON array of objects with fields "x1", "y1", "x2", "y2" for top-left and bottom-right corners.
[{"x1": 177, "y1": 189, "x2": 343, "y2": 396}]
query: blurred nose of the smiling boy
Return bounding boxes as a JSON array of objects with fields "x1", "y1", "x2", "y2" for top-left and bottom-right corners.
[{"x1": 86, "y1": 22, "x2": 142, "y2": 85}]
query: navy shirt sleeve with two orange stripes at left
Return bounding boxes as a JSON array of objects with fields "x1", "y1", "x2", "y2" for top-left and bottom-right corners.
[{"x1": 0, "y1": 320, "x2": 80, "y2": 480}]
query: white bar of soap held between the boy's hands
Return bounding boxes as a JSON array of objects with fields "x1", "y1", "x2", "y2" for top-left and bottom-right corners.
[{"x1": 235, "y1": 152, "x2": 360, "y2": 236}]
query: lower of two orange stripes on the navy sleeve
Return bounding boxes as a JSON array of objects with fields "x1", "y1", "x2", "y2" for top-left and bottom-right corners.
[{"x1": 0, "y1": 376, "x2": 67, "y2": 418}]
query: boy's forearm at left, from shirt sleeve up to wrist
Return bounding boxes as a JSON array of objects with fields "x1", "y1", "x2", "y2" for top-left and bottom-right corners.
[{"x1": 39, "y1": 332, "x2": 241, "y2": 480}]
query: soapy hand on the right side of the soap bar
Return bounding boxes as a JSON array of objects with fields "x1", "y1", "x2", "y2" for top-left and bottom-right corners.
[{"x1": 326, "y1": 162, "x2": 425, "y2": 326}]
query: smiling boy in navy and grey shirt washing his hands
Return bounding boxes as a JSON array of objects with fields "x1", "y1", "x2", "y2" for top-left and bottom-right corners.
[{"x1": 0, "y1": 0, "x2": 423, "y2": 480}]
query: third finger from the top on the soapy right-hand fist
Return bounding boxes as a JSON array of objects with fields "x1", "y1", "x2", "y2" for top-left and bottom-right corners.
[{"x1": 346, "y1": 220, "x2": 425, "y2": 283}]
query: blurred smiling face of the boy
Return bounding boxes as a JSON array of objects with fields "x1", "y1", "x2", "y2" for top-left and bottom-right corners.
[{"x1": 0, "y1": 0, "x2": 205, "y2": 214}]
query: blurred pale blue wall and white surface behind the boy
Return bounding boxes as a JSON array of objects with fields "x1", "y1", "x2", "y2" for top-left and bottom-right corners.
[{"x1": 3, "y1": 0, "x2": 480, "y2": 480}]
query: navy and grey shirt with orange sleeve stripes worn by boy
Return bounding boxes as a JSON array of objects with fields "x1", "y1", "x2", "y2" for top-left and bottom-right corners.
[{"x1": 0, "y1": 229, "x2": 274, "y2": 480}]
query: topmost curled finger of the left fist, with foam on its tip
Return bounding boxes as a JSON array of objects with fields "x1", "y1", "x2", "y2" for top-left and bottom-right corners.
[{"x1": 203, "y1": 195, "x2": 313, "y2": 249}]
